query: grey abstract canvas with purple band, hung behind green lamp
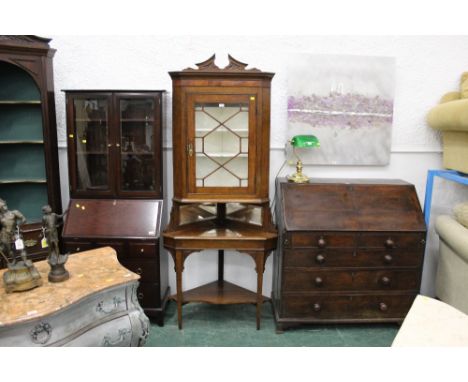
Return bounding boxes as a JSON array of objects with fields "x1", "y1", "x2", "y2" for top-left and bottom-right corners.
[{"x1": 288, "y1": 54, "x2": 395, "y2": 165}]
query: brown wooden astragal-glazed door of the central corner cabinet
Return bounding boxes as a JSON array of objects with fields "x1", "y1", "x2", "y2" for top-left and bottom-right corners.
[{"x1": 186, "y1": 94, "x2": 257, "y2": 197}]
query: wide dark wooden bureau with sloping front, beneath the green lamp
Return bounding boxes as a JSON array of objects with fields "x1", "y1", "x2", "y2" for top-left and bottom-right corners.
[{"x1": 272, "y1": 179, "x2": 426, "y2": 331}]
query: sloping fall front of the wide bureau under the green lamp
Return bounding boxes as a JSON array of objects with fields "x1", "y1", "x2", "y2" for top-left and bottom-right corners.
[{"x1": 277, "y1": 178, "x2": 425, "y2": 231}]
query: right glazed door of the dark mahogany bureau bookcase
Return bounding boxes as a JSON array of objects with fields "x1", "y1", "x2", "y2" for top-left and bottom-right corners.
[{"x1": 115, "y1": 94, "x2": 162, "y2": 197}]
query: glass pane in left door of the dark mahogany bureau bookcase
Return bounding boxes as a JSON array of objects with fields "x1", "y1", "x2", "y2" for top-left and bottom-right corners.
[{"x1": 74, "y1": 98, "x2": 109, "y2": 191}]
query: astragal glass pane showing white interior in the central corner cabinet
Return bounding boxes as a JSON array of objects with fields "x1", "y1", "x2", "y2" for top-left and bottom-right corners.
[{"x1": 195, "y1": 103, "x2": 249, "y2": 187}]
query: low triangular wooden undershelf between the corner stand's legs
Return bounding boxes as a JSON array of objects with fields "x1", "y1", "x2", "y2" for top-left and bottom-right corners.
[{"x1": 170, "y1": 281, "x2": 270, "y2": 305}]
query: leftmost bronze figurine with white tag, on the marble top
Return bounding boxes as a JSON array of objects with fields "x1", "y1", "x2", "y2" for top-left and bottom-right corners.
[{"x1": 0, "y1": 199, "x2": 42, "y2": 293}]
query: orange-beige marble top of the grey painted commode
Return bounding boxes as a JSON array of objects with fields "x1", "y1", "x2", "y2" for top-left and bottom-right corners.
[{"x1": 0, "y1": 247, "x2": 140, "y2": 328}]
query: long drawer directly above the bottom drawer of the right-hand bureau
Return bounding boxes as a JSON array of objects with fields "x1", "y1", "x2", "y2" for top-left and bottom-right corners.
[{"x1": 283, "y1": 269, "x2": 420, "y2": 292}]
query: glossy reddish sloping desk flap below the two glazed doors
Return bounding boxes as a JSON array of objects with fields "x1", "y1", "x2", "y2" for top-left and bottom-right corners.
[{"x1": 62, "y1": 199, "x2": 163, "y2": 239}]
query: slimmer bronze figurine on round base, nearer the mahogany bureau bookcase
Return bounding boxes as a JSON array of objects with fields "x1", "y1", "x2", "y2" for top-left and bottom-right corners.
[{"x1": 42, "y1": 205, "x2": 70, "y2": 283}]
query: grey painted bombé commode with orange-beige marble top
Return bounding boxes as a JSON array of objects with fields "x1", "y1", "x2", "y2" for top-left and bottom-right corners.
[{"x1": 0, "y1": 247, "x2": 149, "y2": 346}]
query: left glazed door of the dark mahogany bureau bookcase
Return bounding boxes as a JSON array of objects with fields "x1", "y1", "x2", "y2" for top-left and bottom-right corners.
[{"x1": 67, "y1": 93, "x2": 114, "y2": 196}]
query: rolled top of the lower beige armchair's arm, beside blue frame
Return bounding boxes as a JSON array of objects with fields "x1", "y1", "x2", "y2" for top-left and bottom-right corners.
[{"x1": 435, "y1": 215, "x2": 468, "y2": 263}]
